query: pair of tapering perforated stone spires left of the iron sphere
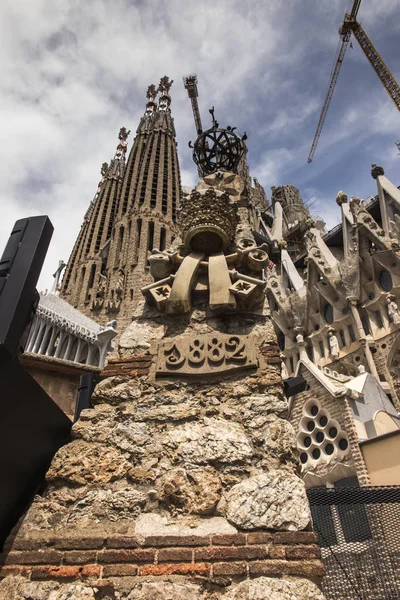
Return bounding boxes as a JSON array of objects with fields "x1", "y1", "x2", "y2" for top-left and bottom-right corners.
[{"x1": 62, "y1": 77, "x2": 181, "y2": 331}]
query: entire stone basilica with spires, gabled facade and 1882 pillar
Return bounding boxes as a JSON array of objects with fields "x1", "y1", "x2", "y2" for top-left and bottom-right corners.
[{"x1": 0, "y1": 77, "x2": 400, "y2": 600}]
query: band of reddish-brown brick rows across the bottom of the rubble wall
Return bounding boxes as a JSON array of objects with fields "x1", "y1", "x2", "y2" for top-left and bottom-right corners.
[{"x1": 0, "y1": 531, "x2": 323, "y2": 582}]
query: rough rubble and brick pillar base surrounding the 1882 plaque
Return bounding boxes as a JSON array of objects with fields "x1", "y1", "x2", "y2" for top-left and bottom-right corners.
[{"x1": 0, "y1": 306, "x2": 322, "y2": 600}]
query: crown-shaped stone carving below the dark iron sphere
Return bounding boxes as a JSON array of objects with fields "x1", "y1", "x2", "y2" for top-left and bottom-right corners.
[{"x1": 179, "y1": 187, "x2": 238, "y2": 255}]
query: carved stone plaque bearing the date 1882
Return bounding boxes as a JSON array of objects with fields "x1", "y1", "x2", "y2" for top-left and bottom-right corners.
[{"x1": 156, "y1": 333, "x2": 257, "y2": 377}]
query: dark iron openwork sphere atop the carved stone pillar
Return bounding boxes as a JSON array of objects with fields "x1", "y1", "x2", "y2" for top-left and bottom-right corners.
[{"x1": 193, "y1": 127, "x2": 244, "y2": 175}]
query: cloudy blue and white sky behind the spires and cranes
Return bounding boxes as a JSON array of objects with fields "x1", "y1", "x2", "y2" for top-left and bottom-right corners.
[{"x1": 0, "y1": 0, "x2": 400, "y2": 290}]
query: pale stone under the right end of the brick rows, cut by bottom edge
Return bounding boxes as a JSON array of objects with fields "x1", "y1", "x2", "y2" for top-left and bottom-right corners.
[{"x1": 224, "y1": 577, "x2": 324, "y2": 600}]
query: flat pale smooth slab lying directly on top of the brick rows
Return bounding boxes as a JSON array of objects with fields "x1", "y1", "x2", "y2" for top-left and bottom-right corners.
[{"x1": 135, "y1": 513, "x2": 237, "y2": 538}]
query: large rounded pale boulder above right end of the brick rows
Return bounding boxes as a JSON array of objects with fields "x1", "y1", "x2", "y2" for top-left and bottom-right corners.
[{"x1": 222, "y1": 469, "x2": 310, "y2": 531}]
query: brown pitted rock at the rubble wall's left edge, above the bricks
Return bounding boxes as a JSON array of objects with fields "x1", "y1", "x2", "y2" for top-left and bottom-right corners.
[{"x1": 46, "y1": 440, "x2": 131, "y2": 485}]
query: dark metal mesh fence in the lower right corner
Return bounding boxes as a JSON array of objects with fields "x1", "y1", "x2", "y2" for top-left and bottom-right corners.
[{"x1": 307, "y1": 486, "x2": 400, "y2": 600}]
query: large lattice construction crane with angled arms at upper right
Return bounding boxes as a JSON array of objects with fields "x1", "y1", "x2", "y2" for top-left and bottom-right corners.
[{"x1": 307, "y1": 0, "x2": 400, "y2": 163}]
